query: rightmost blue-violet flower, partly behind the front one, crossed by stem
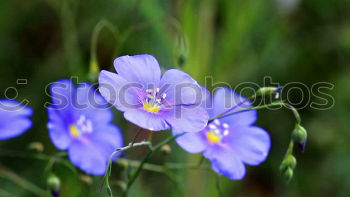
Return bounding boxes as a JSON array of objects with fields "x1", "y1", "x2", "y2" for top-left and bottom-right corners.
[{"x1": 173, "y1": 88, "x2": 270, "y2": 180}]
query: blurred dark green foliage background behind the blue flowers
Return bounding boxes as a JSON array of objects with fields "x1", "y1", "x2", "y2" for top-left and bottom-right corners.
[{"x1": 0, "y1": 0, "x2": 350, "y2": 197}]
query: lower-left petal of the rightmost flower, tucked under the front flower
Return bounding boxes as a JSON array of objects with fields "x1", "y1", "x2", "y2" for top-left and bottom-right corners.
[{"x1": 173, "y1": 131, "x2": 207, "y2": 154}]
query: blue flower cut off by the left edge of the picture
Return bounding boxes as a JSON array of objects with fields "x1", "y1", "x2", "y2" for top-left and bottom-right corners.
[{"x1": 0, "y1": 100, "x2": 33, "y2": 140}]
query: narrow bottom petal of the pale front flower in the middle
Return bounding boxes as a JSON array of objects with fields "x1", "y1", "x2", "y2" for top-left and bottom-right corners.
[{"x1": 124, "y1": 109, "x2": 170, "y2": 131}]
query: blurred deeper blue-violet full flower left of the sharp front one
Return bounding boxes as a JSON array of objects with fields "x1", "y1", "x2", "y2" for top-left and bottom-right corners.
[{"x1": 48, "y1": 80, "x2": 123, "y2": 176}]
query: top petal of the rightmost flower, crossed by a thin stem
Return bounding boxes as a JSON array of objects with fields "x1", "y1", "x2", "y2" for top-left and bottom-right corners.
[{"x1": 210, "y1": 88, "x2": 257, "y2": 126}]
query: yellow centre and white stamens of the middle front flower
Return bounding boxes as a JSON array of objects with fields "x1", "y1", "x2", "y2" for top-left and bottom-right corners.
[{"x1": 143, "y1": 88, "x2": 166, "y2": 113}]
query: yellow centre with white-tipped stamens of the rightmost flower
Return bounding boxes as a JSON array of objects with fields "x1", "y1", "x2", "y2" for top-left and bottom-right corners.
[{"x1": 205, "y1": 119, "x2": 229, "y2": 144}]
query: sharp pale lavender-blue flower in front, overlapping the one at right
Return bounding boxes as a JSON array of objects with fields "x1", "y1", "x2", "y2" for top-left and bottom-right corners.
[{"x1": 99, "y1": 55, "x2": 208, "y2": 132}]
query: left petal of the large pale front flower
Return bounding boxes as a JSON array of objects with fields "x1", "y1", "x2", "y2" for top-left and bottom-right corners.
[{"x1": 99, "y1": 70, "x2": 141, "y2": 111}]
